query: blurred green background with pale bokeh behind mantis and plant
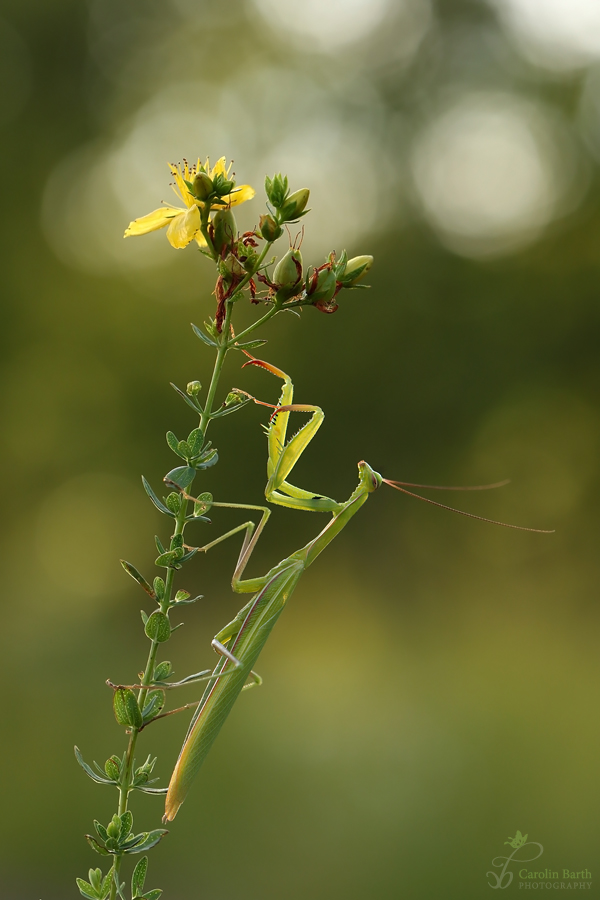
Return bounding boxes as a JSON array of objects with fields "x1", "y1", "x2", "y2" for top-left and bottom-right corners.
[{"x1": 0, "y1": 0, "x2": 600, "y2": 900}]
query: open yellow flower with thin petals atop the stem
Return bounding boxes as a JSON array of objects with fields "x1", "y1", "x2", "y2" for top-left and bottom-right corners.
[{"x1": 124, "y1": 156, "x2": 255, "y2": 250}]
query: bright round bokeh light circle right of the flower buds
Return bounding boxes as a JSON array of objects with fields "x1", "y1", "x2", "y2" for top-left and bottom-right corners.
[{"x1": 411, "y1": 93, "x2": 581, "y2": 257}]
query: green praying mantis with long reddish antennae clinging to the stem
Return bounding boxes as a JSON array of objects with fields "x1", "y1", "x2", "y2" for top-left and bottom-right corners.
[{"x1": 163, "y1": 358, "x2": 540, "y2": 822}]
